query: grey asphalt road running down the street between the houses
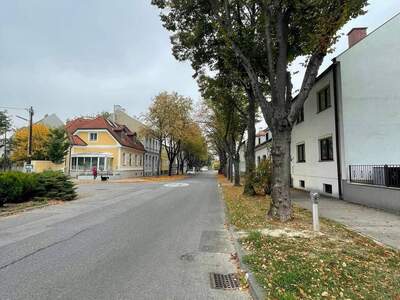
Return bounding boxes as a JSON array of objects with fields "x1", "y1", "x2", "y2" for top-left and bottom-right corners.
[{"x1": 0, "y1": 173, "x2": 249, "y2": 300}]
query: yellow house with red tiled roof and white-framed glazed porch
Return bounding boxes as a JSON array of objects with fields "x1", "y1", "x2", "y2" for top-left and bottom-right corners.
[{"x1": 66, "y1": 117, "x2": 144, "y2": 178}]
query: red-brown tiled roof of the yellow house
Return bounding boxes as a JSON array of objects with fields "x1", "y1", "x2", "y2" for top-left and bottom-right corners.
[{"x1": 65, "y1": 116, "x2": 144, "y2": 151}]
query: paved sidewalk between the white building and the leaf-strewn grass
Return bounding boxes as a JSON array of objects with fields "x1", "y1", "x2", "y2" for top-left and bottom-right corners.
[{"x1": 291, "y1": 190, "x2": 400, "y2": 249}]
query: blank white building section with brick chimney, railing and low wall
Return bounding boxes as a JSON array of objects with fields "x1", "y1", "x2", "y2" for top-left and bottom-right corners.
[{"x1": 336, "y1": 14, "x2": 400, "y2": 212}]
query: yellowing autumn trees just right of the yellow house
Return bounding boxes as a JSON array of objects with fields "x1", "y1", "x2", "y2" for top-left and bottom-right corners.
[{"x1": 142, "y1": 92, "x2": 208, "y2": 176}]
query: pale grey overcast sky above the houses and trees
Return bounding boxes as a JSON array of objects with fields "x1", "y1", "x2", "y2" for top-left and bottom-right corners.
[{"x1": 0, "y1": 0, "x2": 400, "y2": 126}]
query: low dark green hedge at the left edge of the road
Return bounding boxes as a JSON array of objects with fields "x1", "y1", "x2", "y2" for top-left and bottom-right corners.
[{"x1": 0, "y1": 171, "x2": 77, "y2": 206}]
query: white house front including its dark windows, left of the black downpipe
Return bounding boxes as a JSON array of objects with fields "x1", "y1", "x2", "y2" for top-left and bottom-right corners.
[{"x1": 291, "y1": 67, "x2": 339, "y2": 197}]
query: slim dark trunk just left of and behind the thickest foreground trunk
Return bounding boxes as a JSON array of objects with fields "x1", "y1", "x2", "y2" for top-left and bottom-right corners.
[{"x1": 244, "y1": 90, "x2": 256, "y2": 196}]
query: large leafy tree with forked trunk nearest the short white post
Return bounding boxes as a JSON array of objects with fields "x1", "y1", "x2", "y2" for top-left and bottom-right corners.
[{"x1": 152, "y1": 0, "x2": 367, "y2": 221}]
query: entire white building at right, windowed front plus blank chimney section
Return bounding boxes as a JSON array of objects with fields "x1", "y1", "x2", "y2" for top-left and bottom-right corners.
[{"x1": 291, "y1": 14, "x2": 400, "y2": 212}]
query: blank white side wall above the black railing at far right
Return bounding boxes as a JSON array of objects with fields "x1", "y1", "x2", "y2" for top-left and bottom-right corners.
[{"x1": 337, "y1": 15, "x2": 400, "y2": 179}]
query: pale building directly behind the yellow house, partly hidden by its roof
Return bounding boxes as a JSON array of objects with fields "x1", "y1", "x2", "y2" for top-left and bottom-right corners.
[{"x1": 111, "y1": 105, "x2": 160, "y2": 176}]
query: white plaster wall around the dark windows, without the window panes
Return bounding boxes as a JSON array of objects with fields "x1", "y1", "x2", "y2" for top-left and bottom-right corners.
[{"x1": 290, "y1": 71, "x2": 339, "y2": 197}]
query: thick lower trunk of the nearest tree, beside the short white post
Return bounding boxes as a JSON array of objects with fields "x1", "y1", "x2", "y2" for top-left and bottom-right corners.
[{"x1": 268, "y1": 127, "x2": 292, "y2": 222}]
